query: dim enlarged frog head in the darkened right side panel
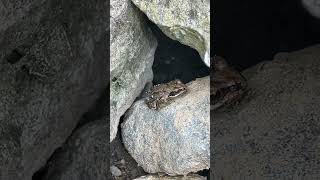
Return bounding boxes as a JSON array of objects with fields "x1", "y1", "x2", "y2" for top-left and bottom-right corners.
[{"x1": 210, "y1": 55, "x2": 247, "y2": 110}]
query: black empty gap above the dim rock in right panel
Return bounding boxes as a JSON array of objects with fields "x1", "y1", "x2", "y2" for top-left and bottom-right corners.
[{"x1": 212, "y1": 0, "x2": 320, "y2": 70}]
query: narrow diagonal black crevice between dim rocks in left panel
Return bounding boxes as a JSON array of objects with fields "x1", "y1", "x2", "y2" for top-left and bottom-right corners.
[{"x1": 32, "y1": 86, "x2": 110, "y2": 180}]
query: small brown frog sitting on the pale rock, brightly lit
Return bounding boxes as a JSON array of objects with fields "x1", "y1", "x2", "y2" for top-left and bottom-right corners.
[{"x1": 145, "y1": 79, "x2": 188, "y2": 111}]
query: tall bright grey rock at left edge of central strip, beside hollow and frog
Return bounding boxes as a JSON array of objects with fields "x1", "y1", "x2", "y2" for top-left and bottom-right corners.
[{"x1": 110, "y1": 0, "x2": 157, "y2": 141}]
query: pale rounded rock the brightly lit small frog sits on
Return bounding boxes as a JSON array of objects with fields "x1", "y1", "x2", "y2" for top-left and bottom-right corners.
[{"x1": 122, "y1": 77, "x2": 210, "y2": 175}]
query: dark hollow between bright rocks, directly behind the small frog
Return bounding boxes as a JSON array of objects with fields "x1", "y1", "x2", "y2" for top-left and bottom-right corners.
[{"x1": 146, "y1": 18, "x2": 210, "y2": 84}]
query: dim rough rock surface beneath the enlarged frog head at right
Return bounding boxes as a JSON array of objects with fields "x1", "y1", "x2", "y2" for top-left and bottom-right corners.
[{"x1": 210, "y1": 45, "x2": 320, "y2": 179}]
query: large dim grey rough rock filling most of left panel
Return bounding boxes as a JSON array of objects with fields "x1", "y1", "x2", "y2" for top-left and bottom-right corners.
[{"x1": 0, "y1": 0, "x2": 108, "y2": 180}]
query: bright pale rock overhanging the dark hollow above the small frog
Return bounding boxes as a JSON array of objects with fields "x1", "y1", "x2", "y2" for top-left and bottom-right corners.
[{"x1": 132, "y1": 0, "x2": 210, "y2": 66}]
